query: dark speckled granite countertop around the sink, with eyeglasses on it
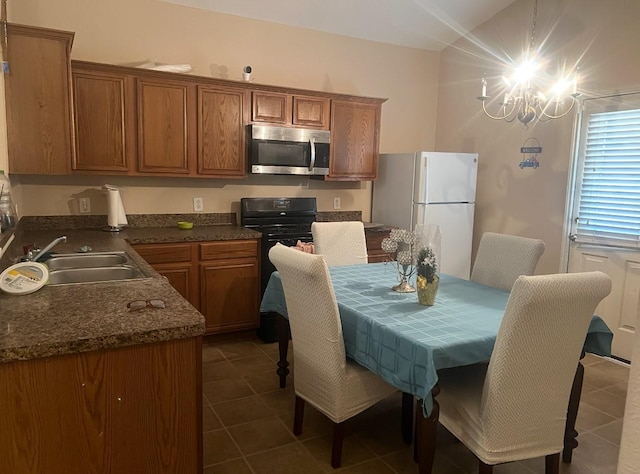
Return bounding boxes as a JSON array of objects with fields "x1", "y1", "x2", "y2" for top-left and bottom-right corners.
[{"x1": 0, "y1": 217, "x2": 261, "y2": 362}]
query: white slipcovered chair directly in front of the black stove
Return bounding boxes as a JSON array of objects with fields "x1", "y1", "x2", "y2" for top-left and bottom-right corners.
[{"x1": 311, "y1": 221, "x2": 369, "y2": 267}]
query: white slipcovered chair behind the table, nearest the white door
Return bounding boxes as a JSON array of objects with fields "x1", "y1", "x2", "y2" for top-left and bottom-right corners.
[{"x1": 471, "y1": 232, "x2": 545, "y2": 290}]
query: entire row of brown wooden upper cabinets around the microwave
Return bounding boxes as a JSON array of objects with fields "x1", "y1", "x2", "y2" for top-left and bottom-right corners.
[{"x1": 5, "y1": 25, "x2": 385, "y2": 181}]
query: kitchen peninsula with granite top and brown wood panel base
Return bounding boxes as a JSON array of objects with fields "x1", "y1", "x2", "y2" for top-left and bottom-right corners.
[{"x1": 0, "y1": 218, "x2": 261, "y2": 474}]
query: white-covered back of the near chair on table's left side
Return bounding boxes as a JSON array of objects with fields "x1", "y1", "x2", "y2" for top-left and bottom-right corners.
[{"x1": 269, "y1": 244, "x2": 346, "y2": 406}]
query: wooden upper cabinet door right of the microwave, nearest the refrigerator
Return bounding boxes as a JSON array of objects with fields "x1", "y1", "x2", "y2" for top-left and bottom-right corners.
[{"x1": 327, "y1": 100, "x2": 381, "y2": 181}]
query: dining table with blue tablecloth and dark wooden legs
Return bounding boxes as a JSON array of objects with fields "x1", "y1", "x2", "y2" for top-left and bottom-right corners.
[{"x1": 260, "y1": 262, "x2": 613, "y2": 473}]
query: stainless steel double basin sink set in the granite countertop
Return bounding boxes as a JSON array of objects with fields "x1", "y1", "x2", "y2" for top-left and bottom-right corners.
[{"x1": 43, "y1": 251, "x2": 148, "y2": 285}]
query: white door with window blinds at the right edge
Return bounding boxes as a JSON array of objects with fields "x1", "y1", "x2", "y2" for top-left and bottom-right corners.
[{"x1": 567, "y1": 94, "x2": 640, "y2": 360}]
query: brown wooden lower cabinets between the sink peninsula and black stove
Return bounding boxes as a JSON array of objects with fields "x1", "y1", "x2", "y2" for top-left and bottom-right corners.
[{"x1": 133, "y1": 239, "x2": 260, "y2": 334}]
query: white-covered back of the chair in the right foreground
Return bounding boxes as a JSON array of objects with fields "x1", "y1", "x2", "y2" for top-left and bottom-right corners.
[{"x1": 480, "y1": 272, "x2": 611, "y2": 457}]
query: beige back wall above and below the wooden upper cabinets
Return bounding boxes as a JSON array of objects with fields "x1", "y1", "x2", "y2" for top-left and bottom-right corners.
[{"x1": 3, "y1": 0, "x2": 439, "y2": 220}]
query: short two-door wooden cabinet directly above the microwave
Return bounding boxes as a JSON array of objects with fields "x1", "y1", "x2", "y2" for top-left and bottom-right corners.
[{"x1": 251, "y1": 91, "x2": 330, "y2": 130}]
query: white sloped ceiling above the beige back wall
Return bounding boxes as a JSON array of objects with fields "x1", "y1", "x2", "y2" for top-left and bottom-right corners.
[{"x1": 159, "y1": 0, "x2": 515, "y2": 51}]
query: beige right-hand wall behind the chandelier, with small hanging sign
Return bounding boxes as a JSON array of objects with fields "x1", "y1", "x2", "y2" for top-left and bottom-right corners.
[{"x1": 436, "y1": 0, "x2": 640, "y2": 273}]
